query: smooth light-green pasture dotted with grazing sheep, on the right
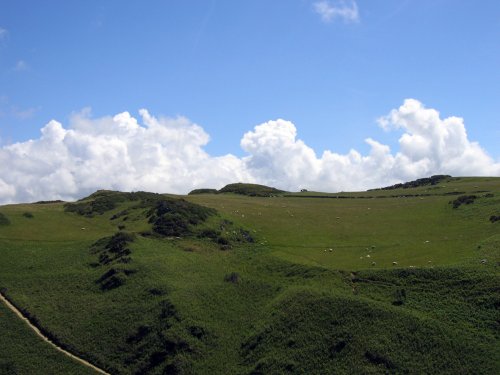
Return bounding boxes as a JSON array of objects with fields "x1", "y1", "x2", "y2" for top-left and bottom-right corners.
[{"x1": 189, "y1": 178, "x2": 500, "y2": 270}]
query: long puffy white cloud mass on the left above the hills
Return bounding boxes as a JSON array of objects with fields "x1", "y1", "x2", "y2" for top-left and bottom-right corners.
[{"x1": 0, "y1": 110, "x2": 251, "y2": 203}]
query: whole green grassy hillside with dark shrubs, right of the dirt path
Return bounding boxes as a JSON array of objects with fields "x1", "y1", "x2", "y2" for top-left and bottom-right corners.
[{"x1": 0, "y1": 178, "x2": 500, "y2": 374}]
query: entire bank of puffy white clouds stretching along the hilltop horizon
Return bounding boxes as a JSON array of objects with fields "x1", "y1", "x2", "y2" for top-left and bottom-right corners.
[{"x1": 0, "y1": 99, "x2": 500, "y2": 204}]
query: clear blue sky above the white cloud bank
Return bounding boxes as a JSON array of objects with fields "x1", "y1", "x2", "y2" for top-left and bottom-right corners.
[{"x1": 0, "y1": 0, "x2": 500, "y2": 204}]
